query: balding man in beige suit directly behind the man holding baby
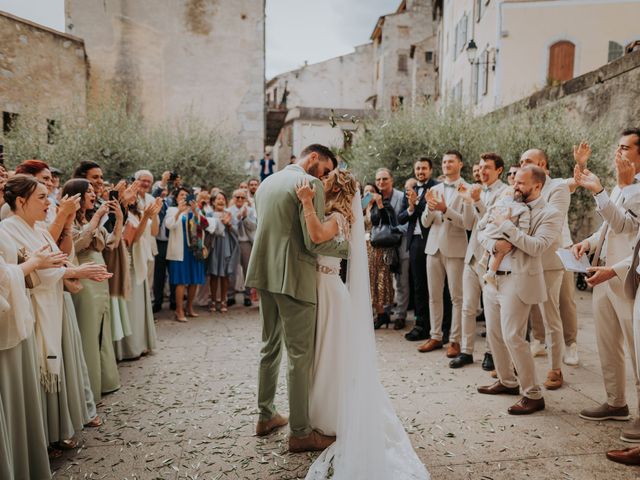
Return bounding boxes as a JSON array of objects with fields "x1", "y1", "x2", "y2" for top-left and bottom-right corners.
[{"x1": 520, "y1": 148, "x2": 571, "y2": 390}]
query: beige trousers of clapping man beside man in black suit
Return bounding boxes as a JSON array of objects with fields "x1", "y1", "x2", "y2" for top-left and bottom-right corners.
[{"x1": 427, "y1": 251, "x2": 462, "y2": 343}]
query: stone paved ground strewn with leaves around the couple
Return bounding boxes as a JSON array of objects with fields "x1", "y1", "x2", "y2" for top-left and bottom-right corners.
[{"x1": 54, "y1": 293, "x2": 640, "y2": 480}]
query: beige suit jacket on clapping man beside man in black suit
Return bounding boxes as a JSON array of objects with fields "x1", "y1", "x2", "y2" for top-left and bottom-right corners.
[{"x1": 421, "y1": 180, "x2": 469, "y2": 258}]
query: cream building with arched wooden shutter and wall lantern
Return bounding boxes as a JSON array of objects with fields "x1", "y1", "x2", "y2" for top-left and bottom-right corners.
[{"x1": 433, "y1": 0, "x2": 640, "y2": 114}]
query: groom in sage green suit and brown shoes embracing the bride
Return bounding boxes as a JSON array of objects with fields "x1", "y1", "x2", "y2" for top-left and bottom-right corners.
[{"x1": 246, "y1": 144, "x2": 349, "y2": 452}]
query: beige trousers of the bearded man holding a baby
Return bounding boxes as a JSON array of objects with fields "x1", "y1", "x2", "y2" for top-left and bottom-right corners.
[{"x1": 484, "y1": 275, "x2": 542, "y2": 400}]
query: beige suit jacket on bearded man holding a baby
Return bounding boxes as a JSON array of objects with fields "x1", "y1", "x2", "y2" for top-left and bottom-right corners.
[{"x1": 478, "y1": 197, "x2": 564, "y2": 305}]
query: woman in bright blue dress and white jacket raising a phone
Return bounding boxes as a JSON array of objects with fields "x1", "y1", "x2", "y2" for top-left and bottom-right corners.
[{"x1": 165, "y1": 187, "x2": 208, "y2": 322}]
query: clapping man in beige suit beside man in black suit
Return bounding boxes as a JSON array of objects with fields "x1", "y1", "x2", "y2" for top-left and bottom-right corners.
[{"x1": 418, "y1": 150, "x2": 469, "y2": 358}]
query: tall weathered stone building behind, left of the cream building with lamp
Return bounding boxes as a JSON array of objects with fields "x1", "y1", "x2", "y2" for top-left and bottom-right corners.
[{"x1": 367, "y1": 0, "x2": 436, "y2": 110}]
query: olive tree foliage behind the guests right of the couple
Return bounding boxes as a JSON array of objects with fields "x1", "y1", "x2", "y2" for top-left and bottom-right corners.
[{"x1": 344, "y1": 105, "x2": 622, "y2": 233}]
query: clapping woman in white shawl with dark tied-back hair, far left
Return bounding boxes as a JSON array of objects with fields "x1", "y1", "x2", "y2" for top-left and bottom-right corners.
[{"x1": 0, "y1": 175, "x2": 109, "y2": 450}]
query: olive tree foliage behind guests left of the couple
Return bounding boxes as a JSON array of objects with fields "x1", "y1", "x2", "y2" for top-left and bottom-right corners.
[{"x1": 4, "y1": 100, "x2": 246, "y2": 191}]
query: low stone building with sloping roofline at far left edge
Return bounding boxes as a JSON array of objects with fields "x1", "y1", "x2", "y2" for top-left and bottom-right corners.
[{"x1": 0, "y1": 12, "x2": 88, "y2": 149}]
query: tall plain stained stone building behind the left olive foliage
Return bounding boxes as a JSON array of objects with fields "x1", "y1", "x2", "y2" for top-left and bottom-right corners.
[{"x1": 65, "y1": 0, "x2": 265, "y2": 155}]
